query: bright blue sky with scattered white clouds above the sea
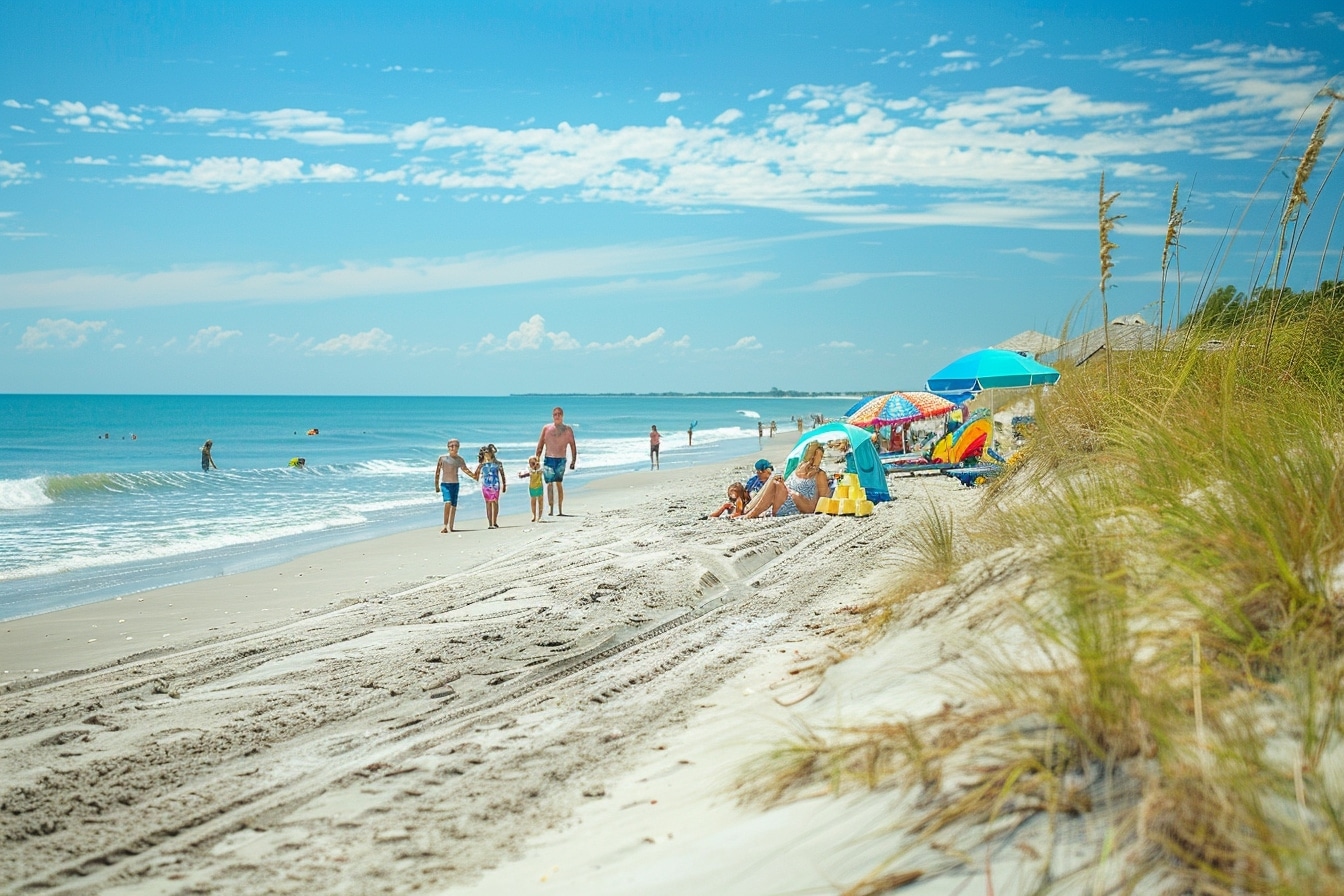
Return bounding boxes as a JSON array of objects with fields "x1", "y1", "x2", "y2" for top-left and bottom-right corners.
[{"x1": 0, "y1": 0, "x2": 1344, "y2": 395}]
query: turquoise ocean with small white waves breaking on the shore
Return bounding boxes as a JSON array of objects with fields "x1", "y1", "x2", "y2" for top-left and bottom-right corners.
[{"x1": 0, "y1": 395, "x2": 855, "y2": 619}]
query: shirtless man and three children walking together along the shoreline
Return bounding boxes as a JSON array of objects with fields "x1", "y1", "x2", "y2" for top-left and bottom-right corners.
[{"x1": 434, "y1": 407, "x2": 579, "y2": 532}]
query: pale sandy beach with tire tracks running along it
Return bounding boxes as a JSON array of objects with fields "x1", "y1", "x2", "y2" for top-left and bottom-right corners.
[{"x1": 0, "y1": 443, "x2": 989, "y2": 893}]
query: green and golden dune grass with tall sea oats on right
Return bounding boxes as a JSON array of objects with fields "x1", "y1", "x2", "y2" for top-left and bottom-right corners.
[{"x1": 743, "y1": 89, "x2": 1344, "y2": 896}]
